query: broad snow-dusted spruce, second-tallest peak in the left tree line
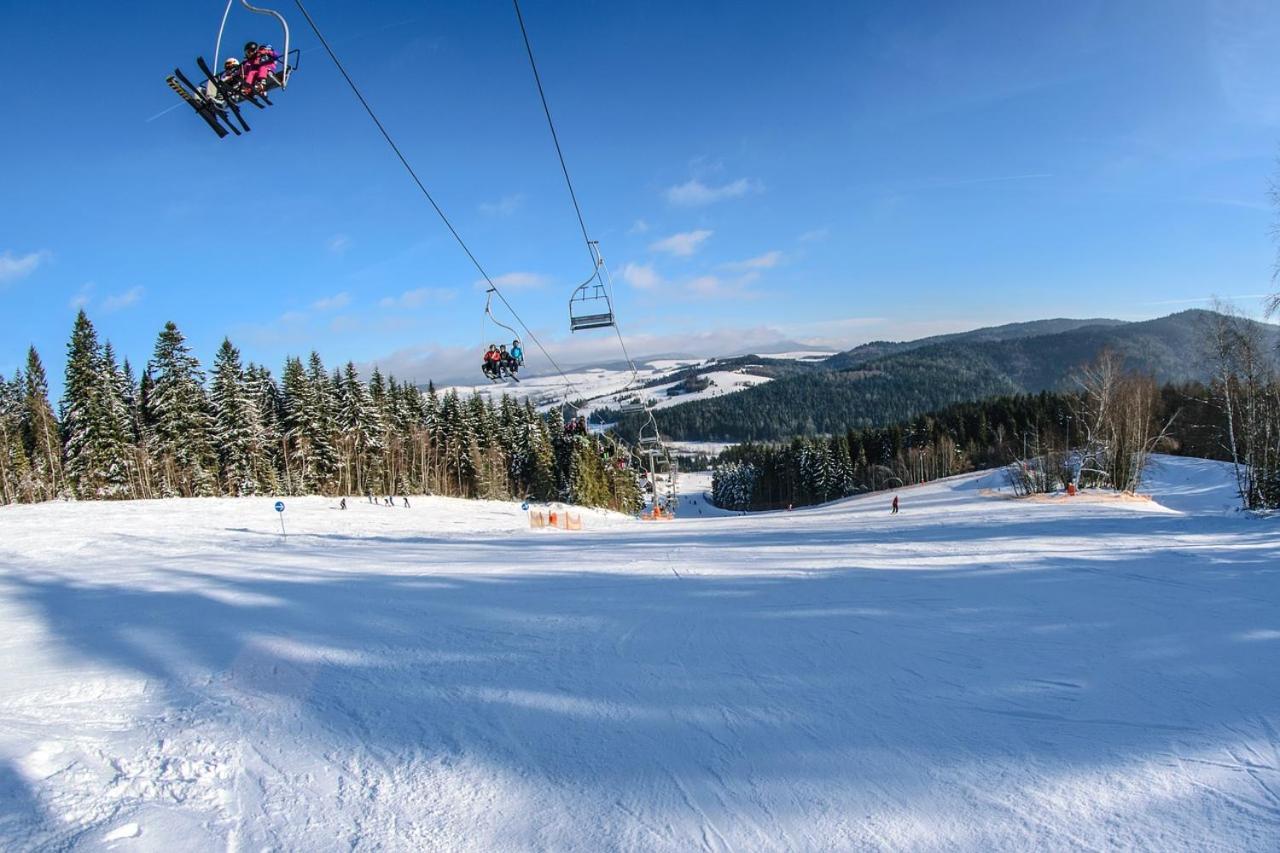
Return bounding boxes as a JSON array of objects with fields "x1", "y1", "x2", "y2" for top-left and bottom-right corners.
[{"x1": 147, "y1": 323, "x2": 216, "y2": 497}]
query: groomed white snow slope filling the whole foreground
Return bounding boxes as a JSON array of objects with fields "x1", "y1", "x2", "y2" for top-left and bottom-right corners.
[{"x1": 0, "y1": 460, "x2": 1280, "y2": 852}]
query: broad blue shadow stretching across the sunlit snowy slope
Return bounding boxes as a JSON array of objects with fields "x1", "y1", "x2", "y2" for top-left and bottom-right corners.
[{"x1": 0, "y1": 504, "x2": 1280, "y2": 845}]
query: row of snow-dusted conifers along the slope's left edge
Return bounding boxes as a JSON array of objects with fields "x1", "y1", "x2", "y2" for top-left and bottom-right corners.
[{"x1": 0, "y1": 311, "x2": 643, "y2": 512}]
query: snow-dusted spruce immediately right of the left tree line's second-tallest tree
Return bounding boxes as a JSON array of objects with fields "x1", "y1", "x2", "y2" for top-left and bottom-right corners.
[{"x1": 210, "y1": 338, "x2": 270, "y2": 496}]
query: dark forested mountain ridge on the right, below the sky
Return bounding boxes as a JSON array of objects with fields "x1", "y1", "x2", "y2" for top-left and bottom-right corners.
[{"x1": 620, "y1": 310, "x2": 1280, "y2": 442}]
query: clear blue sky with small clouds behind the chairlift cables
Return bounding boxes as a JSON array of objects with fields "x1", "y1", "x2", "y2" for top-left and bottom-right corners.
[{"x1": 0, "y1": 0, "x2": 1280, "y2": 380}]
